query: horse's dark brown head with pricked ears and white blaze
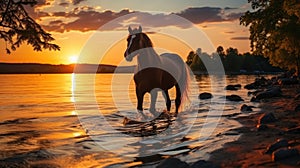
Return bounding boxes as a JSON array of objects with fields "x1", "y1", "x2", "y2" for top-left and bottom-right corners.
[{"x1": 124, "y1": 26, "x2": 152, "y2": 61}]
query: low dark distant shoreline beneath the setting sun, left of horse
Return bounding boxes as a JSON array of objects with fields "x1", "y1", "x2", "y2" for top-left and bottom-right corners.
[{"x1": 0, "y1": 63, "x2": 132, "y2": 74}]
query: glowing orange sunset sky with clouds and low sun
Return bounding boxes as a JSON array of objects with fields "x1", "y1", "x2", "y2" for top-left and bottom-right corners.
[{"x1": 0, "y1": 0, "x2": 250, "y2": 65}]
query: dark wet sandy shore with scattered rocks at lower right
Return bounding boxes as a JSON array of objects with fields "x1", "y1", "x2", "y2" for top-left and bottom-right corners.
[{"x1": 209, "y1": 85, "x2": 300, "y2": 167}]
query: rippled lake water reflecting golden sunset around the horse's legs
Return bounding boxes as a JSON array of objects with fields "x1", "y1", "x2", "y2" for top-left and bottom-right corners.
[{"x1": 0, "y1": 74, "x2": 259, "y2": 167}]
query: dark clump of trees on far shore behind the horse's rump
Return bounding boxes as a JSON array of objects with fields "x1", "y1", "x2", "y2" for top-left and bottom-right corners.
[{"x1": 186, "y1": 46, "x2": 282, "y2": 74}]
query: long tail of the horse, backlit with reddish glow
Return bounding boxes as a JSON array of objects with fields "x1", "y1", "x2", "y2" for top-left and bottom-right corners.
[{"x1": 178, "y1": 62, "x2": 190, "y2": 110}]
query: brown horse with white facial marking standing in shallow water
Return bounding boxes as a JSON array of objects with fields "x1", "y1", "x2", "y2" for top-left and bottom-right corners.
[{"x1": 124, "y1": 26, "x2": 189, "y2": 115}]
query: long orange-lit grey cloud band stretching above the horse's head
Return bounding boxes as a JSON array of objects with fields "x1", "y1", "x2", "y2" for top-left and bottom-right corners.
[{"x1": 35, "y1": 6, "x2": 245, "y2": 32}]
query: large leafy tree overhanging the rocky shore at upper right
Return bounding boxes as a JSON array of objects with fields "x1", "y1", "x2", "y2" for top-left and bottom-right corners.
[{"x1": 240, "y1": 0, "x2": 300, "y2": 74}]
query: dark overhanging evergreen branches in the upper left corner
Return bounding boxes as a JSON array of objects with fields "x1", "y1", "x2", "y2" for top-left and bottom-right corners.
[{"x1": 0, "y1": 0, "x2": 60, "y2": 54}]
